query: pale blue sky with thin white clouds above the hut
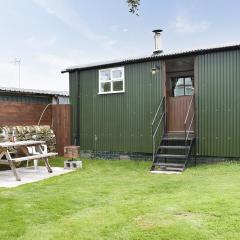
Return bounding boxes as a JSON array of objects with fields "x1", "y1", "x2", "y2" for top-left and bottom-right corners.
[{"x1": 0, "y1": 0, "x2": 240, "y2": 90}]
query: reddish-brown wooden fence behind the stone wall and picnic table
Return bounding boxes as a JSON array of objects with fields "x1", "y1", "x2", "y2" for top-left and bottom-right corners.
[{"x1": 0, "y1": 101, "x2": 71, "y2": 156}]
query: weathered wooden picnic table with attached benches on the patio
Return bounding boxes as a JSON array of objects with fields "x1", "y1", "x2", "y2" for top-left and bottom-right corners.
[{"x1": 0, "y1": 140, "x2": 57, "y2": 181}]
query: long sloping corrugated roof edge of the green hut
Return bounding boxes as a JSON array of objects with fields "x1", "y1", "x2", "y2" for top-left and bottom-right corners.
[{"x1": 62, "y1": 44, "x2": 240, "y2": 73}]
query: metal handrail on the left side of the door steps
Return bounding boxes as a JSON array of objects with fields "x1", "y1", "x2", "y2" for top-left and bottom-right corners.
[{"x1": 152, "y1": 96, "x2": 166, "y2": 161}]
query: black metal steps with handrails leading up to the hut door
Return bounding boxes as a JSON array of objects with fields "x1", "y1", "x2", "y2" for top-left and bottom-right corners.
[{"x1": 151, "y1": 95, "x2": 195, "y2": 172}]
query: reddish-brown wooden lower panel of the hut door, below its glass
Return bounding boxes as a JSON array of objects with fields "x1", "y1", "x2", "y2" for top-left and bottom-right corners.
[{"x1": 167, "y1": 96, "x2": 194, "y2": 132}]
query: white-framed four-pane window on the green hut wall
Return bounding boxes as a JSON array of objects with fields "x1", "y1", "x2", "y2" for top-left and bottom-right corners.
[{"x1": 99, "y1": 67, "x2": 125, "y2": 94}]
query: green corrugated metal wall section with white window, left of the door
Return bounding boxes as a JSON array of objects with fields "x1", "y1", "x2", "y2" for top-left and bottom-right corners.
[{"x1": 70, "y1": 62, "x2": 162, "y2": 153}]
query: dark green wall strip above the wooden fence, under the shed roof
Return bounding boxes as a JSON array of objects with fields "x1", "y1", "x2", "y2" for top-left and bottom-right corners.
[{"x1": 0, "y1": 93, "x2": 52, "y2": 104}]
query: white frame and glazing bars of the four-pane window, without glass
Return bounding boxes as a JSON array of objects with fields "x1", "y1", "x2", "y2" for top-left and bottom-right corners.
[{"x1": 98, "y1": 67, "x2": 125, "y2": 94}]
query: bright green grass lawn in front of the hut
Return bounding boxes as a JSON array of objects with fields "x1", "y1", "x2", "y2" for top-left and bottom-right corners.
[{"x1": 0, "y1": 159, "x2": 240, "y2": 240}]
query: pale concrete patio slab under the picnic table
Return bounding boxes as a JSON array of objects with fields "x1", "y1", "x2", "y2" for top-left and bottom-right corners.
[{"x1": 0, "y1": 167, "x2": 74, "y2": 188}]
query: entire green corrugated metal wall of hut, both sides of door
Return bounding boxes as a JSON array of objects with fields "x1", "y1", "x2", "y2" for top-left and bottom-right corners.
[{"x1": 70, "y1": 50, "x2": 240, "y2": 157}]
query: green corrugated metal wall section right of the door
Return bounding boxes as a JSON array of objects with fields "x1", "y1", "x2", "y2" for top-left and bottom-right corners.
[{"x1": 196, "y1": 50, "x2": 240, "y2": 157}]
